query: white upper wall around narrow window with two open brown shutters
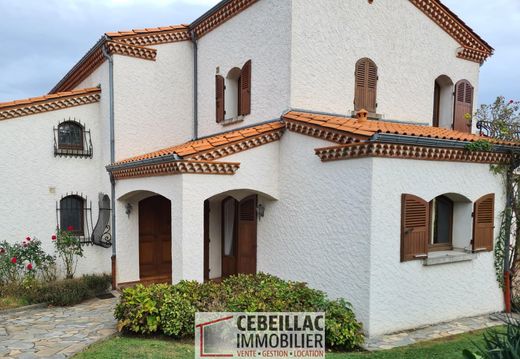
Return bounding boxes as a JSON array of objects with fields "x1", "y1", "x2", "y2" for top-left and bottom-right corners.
[{"x1": 198, "y1": 0, "x2": 291, "y2": 136}]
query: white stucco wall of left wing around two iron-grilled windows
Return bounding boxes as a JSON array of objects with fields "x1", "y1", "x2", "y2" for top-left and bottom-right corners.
[{"x1": 0, "y1": 103, "x2": 110, "y2": 274}]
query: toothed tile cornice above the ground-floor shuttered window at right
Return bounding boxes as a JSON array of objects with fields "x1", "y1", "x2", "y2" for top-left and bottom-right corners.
[{"x1": 315, "y1": 142, "x2": 510, "y2": 163}]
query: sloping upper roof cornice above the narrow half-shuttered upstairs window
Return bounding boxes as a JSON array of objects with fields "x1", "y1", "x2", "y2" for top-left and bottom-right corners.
[{"x1": 190, "y1": 0, "x2": 258, "y2": 38}]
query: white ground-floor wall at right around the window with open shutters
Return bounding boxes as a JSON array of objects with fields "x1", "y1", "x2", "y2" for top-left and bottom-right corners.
[{"x1": 370, "y1": 159, "x2": 504, "y2": 335}]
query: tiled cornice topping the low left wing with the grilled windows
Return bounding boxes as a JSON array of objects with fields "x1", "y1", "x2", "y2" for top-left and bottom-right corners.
[{"x1": 0, "y1": 87, "x2": 101, "y2": 121}]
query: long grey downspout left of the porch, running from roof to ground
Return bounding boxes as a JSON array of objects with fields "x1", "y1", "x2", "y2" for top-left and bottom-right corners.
[{"x1": 102, "y1": 40, "x2": 117, "y2": 289}]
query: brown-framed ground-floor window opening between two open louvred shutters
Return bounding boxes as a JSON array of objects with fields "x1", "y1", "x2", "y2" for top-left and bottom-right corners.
[{"x1": 430, "y1": 196, "x2": 453, "y2": 250}]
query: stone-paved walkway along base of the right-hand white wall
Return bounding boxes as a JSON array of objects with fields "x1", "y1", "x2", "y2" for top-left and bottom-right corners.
[{"x1": 365, "y1": 314, "x2": 516, "y2": 351}]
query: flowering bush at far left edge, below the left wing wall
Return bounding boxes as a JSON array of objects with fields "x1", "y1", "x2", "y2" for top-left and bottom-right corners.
[{"x1": 0, "y1": 237, "x2": 55, "y2": 284}]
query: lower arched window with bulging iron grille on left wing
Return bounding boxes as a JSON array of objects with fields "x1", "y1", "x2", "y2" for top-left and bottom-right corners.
[{"x1": 56, "y1": 192, "x2": 94, "y2": 245}]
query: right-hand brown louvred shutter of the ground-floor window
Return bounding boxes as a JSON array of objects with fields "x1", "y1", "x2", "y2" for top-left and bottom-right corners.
[{"x1": 473, "y1": 193, "x2": 495, "y2": 252}]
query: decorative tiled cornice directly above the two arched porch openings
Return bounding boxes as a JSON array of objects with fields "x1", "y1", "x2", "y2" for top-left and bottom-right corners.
[{"x1": 107, "y1": 160, "x2": 240, "y2": 180}]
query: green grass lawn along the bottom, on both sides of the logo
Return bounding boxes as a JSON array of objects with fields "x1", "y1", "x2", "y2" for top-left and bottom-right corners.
[{"x1": 74, "y1": 331, "x2": 500, "y2": 359}]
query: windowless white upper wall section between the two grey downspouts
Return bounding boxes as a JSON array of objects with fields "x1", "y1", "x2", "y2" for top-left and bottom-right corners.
[{"x1": 114, "y1": 41, "x2": 193, "y2": 160}]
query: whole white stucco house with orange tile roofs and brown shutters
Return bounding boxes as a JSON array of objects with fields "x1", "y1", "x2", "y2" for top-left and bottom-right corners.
[{"x1": 0, "y1": 0, "x2": 514, "y2": 335}]
